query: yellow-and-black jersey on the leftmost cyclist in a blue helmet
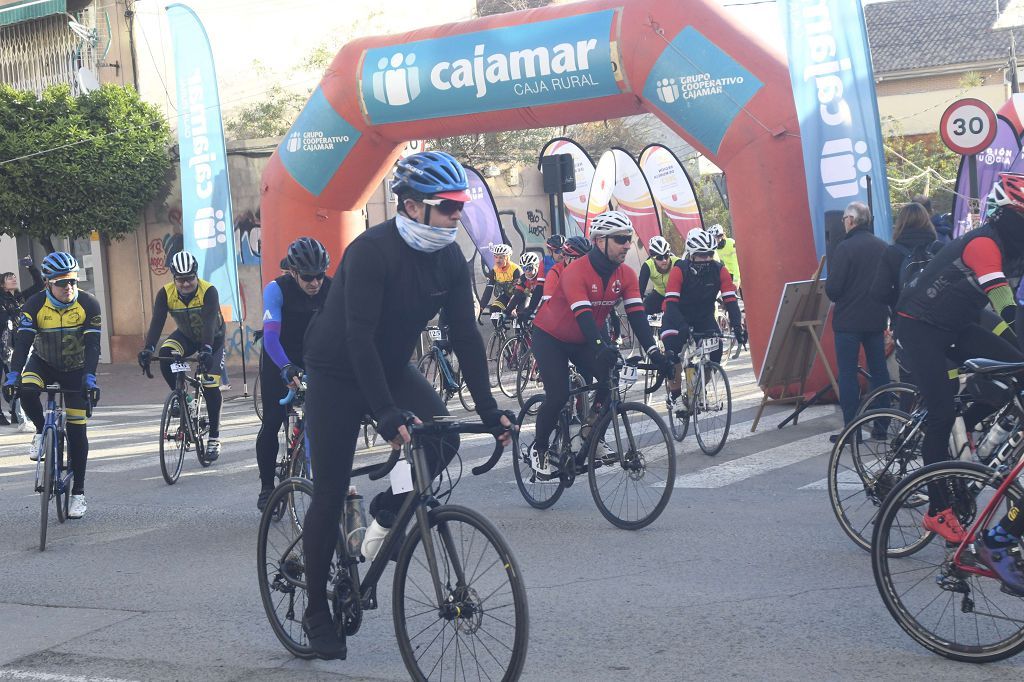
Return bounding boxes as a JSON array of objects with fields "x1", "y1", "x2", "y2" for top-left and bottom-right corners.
[{"x1": 11, "y1": 291, "x2": 101, "y2": 374}]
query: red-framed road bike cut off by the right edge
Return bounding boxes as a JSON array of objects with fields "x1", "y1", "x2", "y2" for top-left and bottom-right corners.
[{"x1": 871, "y1": 359, "x2": 1024, "y2": 663}]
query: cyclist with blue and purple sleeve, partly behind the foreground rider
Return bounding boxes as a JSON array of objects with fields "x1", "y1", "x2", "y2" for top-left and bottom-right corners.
[{"x1": 256, "y1": 237, "x2": 331, "y2": 511}]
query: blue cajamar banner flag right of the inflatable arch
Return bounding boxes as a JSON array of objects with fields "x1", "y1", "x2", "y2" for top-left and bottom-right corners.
[{"x1": 778, "y1": 0, "x2": 892, "y2": 257}]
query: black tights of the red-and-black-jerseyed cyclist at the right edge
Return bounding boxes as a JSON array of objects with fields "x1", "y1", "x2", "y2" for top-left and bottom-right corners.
[{"x1": 896, "y1": 316, "x2": 1024, "y2": 513}]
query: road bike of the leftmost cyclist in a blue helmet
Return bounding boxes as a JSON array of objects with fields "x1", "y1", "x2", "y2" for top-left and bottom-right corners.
[{"x1": 35, "y1": 384, "x2": 92, "y2": 552}]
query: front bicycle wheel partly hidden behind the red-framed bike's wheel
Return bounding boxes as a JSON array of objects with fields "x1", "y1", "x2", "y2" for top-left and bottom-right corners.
[{"x1": 827, "y1": 410, "x2": 928, "y2": 554}]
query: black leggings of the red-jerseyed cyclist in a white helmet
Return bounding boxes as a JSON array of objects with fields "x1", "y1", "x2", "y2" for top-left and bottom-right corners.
[{"x1": 532, "y1": 328, "x2": 611, "y2": 453}]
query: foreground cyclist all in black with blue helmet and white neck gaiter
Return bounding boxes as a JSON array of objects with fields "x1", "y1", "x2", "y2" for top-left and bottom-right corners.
[{"x1": 302, "y1": 152, "x2": 512, "y2": 658}]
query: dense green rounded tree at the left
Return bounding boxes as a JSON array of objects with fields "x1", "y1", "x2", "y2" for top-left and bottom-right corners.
[{"x1": 0, "y1": 84, "x2": 171, "y2": 245}]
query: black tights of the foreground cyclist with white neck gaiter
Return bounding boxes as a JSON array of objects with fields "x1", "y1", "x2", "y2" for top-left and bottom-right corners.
[{"x1": 302, "y1": 365, "x2": 459, "y2": 613}]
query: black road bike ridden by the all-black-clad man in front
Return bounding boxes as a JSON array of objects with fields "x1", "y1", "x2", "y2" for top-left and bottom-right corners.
[{"x1": 257, "y1": 420, "x2": 529, "y2": 680}]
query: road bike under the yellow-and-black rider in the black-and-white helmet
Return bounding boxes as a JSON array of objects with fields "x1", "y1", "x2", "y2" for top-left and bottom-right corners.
[{"x1": 142, "y1": 353, "x2": 213, "y2": 485}]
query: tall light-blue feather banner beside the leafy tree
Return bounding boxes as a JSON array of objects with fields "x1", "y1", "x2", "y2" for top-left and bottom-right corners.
[{"x1": 167, "y1": 4, "x2": 242, "y2": 319}]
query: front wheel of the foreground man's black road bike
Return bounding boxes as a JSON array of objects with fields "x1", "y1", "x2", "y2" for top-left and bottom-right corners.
[{"x1": 392, "y1": 505, "x2": 529, "y2": 680}]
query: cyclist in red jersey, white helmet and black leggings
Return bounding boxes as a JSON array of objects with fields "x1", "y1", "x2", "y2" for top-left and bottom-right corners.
[{"x1": 532, "y1": 211, "x2": 666, "y2": 473}]
